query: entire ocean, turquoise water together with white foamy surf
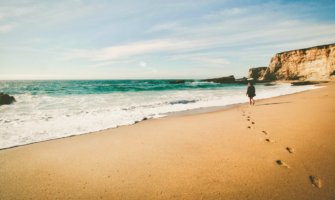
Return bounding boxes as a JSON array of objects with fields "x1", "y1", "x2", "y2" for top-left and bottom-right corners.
[{"x1": 0, "y1": 80, "x2": 317, "y2": 149}]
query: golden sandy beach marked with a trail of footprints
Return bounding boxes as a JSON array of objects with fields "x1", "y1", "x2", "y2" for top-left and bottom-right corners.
[{"x1": 0, "y1": 83, "x2": 335, "y2": 200}]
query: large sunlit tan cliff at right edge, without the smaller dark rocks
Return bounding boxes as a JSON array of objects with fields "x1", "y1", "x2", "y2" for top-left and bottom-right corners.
[{"x1": 258, "y1": 44, "x2": 335, "y2": 81}]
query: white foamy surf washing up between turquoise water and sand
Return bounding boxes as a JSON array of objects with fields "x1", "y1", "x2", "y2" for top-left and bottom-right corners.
[{"x1": 0, "y1": 83, "x2": 317, "y2": 149}]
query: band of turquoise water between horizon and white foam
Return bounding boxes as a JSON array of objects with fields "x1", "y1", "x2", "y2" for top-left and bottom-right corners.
[{"x1": 0, "y1": 80, "x2": 244, "y2": 95}]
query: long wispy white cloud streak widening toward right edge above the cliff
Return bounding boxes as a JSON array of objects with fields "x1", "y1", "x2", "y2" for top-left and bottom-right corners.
[{"x1": 67, "y1": 16, "x2": 335, "y2": 65}]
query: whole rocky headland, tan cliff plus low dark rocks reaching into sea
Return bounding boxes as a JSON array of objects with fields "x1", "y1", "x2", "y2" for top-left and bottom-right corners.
[{"x1": 202, "y1": 44, "x2": 335, "y2": 83}]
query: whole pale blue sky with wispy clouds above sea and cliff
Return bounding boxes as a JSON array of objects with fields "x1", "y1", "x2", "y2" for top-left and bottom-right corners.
[{"x1": 0, "y1": 0, "x2": 335, "y2": 80}]
